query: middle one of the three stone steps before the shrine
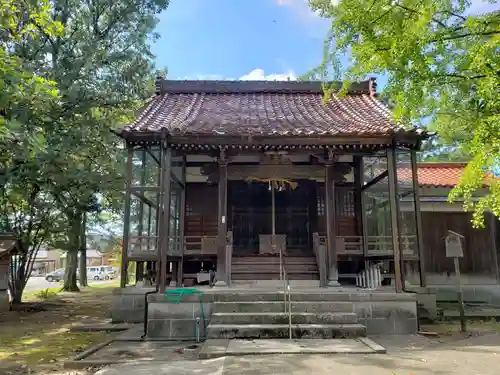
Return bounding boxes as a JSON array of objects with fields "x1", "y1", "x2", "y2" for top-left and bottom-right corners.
[{"x1": 210, "y1": 312, "x2": 358, "y2": 324}]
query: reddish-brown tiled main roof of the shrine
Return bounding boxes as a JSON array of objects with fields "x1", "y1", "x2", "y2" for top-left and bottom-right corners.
[{"x1": 119, "y1": 80, "x2": 426, "y2": 138}]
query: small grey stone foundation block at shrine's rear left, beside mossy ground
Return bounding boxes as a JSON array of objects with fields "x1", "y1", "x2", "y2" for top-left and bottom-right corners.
[{"x1": 111, "y1": 287, "x2": 154, "y2": 323}]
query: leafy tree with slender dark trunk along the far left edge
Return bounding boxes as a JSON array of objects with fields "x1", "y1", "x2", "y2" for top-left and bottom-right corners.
[{"x1": 0, "y1": 0, "x2": 62, "y2": 303}]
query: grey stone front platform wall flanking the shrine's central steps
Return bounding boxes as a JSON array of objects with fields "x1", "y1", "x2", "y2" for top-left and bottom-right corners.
[{"x1": 147, "y1": 290, "x2": 418, "y2": 340}]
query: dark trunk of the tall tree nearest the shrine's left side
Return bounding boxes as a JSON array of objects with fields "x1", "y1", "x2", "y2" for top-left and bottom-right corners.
[{"x1": 62, "y1": 212, "x2": 82, "y2": 292}]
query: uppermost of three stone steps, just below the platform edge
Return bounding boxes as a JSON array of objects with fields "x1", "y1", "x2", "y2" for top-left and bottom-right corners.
[{"x1": 214, "y1": 302, "x2": 354, "y2": 313}]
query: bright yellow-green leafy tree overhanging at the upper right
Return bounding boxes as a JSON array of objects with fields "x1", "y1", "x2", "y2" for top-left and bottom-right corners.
[{"x1": 309, "y1": 0, "x2": 500, "y2": 226}]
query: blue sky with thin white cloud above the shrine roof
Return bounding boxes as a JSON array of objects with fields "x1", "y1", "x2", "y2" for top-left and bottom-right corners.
[{"x1": 153, "y1": 0, "x2": 500, "y2": 88}]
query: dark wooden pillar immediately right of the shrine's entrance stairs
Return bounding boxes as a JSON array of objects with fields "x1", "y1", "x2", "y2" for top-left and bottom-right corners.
[{"x1": 325, "y1": 152, "x2": 340, "y2": 286}]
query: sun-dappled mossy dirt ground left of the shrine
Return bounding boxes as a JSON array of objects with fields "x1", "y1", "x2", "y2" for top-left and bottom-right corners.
[{"x1": 0, "y1": 285, "x2": 114, "y2": 375}]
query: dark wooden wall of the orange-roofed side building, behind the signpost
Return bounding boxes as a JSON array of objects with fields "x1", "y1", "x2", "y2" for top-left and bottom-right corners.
[{"x1": 422, "y1": 212, "x2": 496, "y2": 275}]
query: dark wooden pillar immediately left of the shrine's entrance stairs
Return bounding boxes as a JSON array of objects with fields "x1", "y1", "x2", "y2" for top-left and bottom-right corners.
[{"x1": 215, "y1": 150, "x2": 230, "y2": 286}]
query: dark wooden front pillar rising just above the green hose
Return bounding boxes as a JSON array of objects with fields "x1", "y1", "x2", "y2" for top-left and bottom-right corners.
[{"x1": 159, "y1": 142, "x2": 172, "y2": 293}]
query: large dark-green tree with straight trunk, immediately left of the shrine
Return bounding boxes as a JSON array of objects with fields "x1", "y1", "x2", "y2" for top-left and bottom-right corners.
[{"x1": 38, "y1": 0, "x2": 168, "y2": 291}]
